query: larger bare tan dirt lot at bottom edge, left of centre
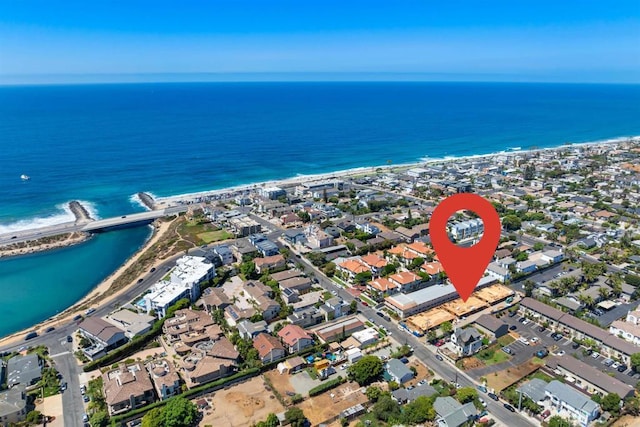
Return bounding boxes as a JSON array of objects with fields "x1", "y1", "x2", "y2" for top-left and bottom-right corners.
[{"x1": 197, "y1": 377, "x2": 285, "y2": 427}]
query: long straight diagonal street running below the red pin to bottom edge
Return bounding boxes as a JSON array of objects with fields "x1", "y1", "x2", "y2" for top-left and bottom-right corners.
[{"x1": 291, "y1": 252, "x2": 538, "y2": 427}]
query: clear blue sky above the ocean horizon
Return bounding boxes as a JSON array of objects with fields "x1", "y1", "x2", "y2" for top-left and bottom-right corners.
[{"x1": 0, "y1": 0, "x2": 640, "y2": 83}]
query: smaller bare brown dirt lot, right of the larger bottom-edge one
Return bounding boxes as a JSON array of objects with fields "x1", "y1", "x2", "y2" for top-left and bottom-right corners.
[{"x1": 298, "y1": 382, "x2": 367, "y2": 426}]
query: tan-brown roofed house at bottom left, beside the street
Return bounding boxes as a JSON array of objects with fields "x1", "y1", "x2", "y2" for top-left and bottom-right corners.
[{"x1": 102, "y1": 363, "x2": 154, "y2": 416}]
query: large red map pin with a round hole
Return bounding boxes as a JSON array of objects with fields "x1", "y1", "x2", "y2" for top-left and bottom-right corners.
[{"x1": 429, "y1": 193, "x2": 501, "y2": 301}]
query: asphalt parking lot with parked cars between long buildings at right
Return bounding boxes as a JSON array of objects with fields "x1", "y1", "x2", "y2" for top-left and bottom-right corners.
[{"x1": 502, "y1": 315, "x2": 640, "y2": 386}]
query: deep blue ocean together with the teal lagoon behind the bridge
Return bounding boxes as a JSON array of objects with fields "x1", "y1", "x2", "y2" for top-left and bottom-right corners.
[{"x1": 0, "y1": 82, "x2": 640, "y2": 336}]
